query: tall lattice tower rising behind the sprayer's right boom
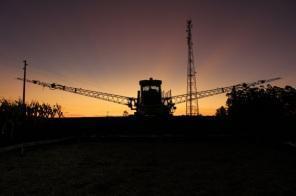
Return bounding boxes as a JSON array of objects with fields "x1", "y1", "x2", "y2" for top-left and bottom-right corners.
[{"x1": 186, "y1": 20, "x2": 199, "y2": 116}]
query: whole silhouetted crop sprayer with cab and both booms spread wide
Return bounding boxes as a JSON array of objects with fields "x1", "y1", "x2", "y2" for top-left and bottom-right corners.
[{"x1": 18, "y1": 78, "x2": 280, "y2": 116}]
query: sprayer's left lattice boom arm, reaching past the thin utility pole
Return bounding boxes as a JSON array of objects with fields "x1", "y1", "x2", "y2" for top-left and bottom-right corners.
[{"x1": 17, "y1": 78, "x2": 137, "y2": 109}]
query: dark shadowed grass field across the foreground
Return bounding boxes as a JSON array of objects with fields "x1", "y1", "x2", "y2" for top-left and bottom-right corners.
[{"x1": 0, "y1": 140, "x2": 296, "y2": 195}]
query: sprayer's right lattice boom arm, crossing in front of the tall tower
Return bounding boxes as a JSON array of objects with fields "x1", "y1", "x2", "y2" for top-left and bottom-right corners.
[{"x1": 172, "y1": 78, "x2": 281, "y2": 104}]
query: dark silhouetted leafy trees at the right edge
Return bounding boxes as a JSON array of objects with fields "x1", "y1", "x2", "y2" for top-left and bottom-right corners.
[{"x1": 216, "y1": 85, "x2": 296, "y2": 138}]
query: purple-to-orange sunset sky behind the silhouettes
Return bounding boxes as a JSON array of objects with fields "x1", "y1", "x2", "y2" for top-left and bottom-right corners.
[{"x1": 0, "y1": 0, "x2": 296, "y2": 116}]
